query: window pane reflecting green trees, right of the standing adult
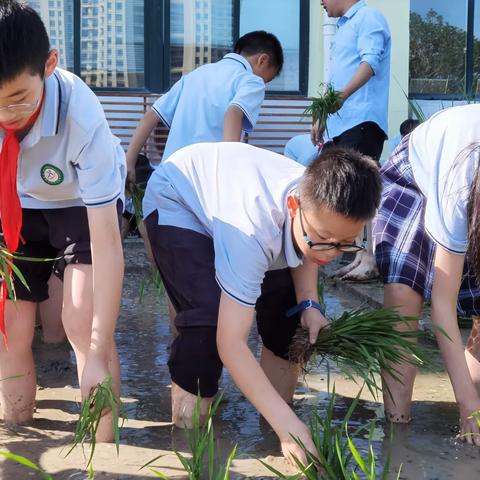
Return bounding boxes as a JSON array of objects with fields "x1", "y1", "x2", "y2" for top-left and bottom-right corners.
[{"x1": 410, "y1": 0, "x2": 466, "y2": 95}]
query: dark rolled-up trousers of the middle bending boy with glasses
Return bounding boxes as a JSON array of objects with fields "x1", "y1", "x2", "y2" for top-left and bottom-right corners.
[{"x1": 145, "y1": 212, "x2": 300, "y2": 397}]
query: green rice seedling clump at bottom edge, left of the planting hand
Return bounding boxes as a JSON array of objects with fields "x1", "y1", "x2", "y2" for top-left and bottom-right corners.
[{"x1": 140, "y1": 395, "x2": 237, "y2": 480}]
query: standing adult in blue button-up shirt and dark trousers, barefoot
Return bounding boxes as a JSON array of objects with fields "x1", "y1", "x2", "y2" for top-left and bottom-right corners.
[{"x1": 312, "y1": 0, "x2": 391, "y2": 280}]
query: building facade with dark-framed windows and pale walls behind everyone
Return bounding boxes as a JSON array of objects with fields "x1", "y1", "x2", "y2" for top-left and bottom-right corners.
[{"x1": 29, "y1": 0, "x2": 480, "y2": 142}]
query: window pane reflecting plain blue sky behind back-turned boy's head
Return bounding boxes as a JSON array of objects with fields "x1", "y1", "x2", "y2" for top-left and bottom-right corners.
[{"x1": 240, "y1": 0, "x2": 300, "y2": 91}]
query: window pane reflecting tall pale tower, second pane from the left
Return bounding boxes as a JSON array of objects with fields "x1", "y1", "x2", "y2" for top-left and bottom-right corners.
[{"x1": 80, "y1": 0, "x2": 145, "y2": 88}]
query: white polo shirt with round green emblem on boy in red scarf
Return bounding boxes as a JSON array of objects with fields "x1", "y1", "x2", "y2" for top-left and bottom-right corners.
[{"x1": 0, "y1": 69, "x2": 126, "y2": 209}]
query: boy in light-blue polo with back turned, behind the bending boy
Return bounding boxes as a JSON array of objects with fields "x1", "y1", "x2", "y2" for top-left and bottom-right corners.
[{"x1": 127, "y1": 31, "x2": 283, "y2": 182}]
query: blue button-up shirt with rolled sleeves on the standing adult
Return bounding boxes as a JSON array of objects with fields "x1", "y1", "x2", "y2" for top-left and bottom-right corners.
[{"x1": 327, "y1": 0, "x2": 391, "y2": 138}]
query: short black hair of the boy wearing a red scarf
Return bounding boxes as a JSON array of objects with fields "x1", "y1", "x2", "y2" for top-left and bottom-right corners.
[{"x1": 0, "y1": 0, "x2": 50, "y2": 85}]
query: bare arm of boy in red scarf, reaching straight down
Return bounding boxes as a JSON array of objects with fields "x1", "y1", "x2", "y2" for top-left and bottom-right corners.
[{"x1": 81, "y1": 203, "x2": 124, "y2": 398}]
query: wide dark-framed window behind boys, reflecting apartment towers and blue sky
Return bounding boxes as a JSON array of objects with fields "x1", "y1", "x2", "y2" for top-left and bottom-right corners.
[{"x1": 25, "y1": 0, "x2": 308, "y2": 94}]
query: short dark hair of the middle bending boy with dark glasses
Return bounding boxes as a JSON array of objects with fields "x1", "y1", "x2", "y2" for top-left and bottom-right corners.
[{"x1": 299, "y1": 148, "x2": 382, "y2": 221}]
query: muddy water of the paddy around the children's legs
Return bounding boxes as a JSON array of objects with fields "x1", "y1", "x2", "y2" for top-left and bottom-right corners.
[{"x1": 0, "y1": 242, "x2": 480, "y2": 480}]
